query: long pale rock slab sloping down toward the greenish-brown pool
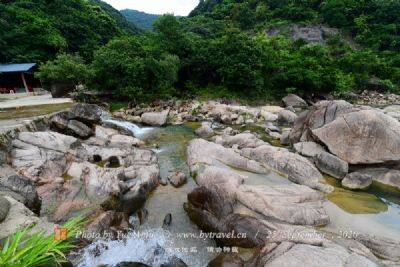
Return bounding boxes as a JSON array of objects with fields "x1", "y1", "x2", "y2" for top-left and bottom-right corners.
[{"x1": 242, "y1": 145, "x2": 333, "y2": 192}]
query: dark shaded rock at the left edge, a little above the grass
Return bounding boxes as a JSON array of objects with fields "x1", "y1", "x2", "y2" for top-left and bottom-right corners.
[{"x1": 0, "y1": 175, "x2": 42, "y2": 214}]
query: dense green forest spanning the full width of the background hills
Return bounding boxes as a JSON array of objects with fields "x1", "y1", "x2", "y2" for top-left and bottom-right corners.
[{"x1": 0, "y1": 0, "x2": 400, "y2": 100}]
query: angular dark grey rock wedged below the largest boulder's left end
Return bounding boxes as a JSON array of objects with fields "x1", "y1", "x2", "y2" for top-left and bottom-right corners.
[{"x1": 315, "y1": 152, "x2": 349, "y2": 179}]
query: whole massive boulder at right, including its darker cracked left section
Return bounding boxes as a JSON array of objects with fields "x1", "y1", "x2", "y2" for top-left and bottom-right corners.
[{"x1": 290, "y1": 100, "x2": 400, "y2": 164}]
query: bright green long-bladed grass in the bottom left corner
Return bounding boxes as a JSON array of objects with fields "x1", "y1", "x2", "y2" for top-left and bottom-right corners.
[{"x1": 0, "y1": 217, "x2": 84, "y2": 267}]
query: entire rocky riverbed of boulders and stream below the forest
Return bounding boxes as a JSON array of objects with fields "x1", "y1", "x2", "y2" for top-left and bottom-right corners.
[{"x1": 0, "y1": 95, "x2": 400, "y2": 266}]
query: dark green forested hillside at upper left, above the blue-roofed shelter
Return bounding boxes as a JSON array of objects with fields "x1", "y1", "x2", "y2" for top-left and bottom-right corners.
[{"x1": 0, "y1": 0, "x2": 139, "y2": 62}]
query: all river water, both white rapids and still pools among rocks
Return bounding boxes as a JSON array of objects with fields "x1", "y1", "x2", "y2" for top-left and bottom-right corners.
[{"x1": 80, "y1": 120, "x2": 400, "y2": 267}]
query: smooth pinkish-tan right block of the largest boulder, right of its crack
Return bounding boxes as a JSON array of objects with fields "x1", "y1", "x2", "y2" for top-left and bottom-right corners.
[{"x1": 312, "y1": 110, "x2": 400, "y2": 164}]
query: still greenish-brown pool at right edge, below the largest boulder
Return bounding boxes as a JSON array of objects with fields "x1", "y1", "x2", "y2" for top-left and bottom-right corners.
[{"x1": 324, "y1": 176, "x2": 400, "y2": 238}]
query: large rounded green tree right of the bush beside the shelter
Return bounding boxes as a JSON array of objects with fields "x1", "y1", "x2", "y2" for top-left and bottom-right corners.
[{"x1": 90, "y1": 37, "x2": 179, "y2": 100}]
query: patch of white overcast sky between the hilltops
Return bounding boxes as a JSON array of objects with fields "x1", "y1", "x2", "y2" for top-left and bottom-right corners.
[{"x1": 103, "y1": 0, "x2": 199, "y2": 16}]
